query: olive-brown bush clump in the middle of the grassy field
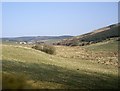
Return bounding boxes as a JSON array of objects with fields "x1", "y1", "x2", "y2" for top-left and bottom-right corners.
[{"x1": 32, "y1": 44, "x2": 56, "y2": 54}]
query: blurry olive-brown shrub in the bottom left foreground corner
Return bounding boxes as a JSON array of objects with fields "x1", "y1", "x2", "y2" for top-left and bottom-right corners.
[{"x1": 2, "y1": 73, "x2": 30, "y2": 89}]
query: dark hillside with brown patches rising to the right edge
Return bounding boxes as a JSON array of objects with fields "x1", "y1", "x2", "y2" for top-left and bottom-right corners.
[{"x1": 57, "y1": 23, "x2": 120, "y2": 46}]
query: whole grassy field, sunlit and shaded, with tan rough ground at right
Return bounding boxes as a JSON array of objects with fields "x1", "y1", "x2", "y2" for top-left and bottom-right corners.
[{"x1": 0, "y1": 40, "x2": 118, "y2": 89}]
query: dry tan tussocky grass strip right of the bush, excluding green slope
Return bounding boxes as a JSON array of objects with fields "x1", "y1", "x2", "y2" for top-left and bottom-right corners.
[{"x1": 56, "y1": 46, "x2": 118, "y2": 66}]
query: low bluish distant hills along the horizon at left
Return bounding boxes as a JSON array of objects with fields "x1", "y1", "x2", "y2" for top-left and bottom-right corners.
[{"x1": 2, "y1": 35, "x2": 73, "y2": 43}]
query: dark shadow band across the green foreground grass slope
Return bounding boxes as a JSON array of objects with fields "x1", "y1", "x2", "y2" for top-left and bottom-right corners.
[{"x1": 2, "y1": 60, "x2": 118, "y2": 89}]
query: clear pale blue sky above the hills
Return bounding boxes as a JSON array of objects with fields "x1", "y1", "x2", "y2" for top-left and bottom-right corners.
[{"x1": 2, "y1": 2, "x2": 118, "y2": 37}]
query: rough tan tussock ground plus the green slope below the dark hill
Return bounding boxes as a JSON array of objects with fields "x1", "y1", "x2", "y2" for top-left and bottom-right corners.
[{"x1": 56, "y1": 41, "x2": 119, "y2": 67}]
